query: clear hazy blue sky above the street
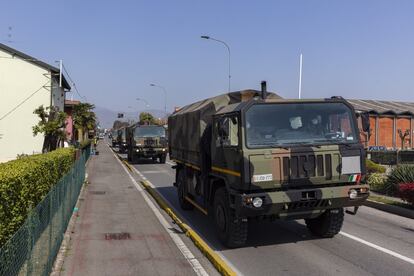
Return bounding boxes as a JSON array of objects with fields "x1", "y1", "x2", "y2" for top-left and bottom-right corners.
[{"x1": 0, "y1": 0, "x2": 414, "y2": 111}]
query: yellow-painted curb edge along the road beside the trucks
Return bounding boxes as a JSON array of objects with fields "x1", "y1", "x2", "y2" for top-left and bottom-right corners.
[{"x1": 116, "y1": 154, "x2": 237, "y2": 276}]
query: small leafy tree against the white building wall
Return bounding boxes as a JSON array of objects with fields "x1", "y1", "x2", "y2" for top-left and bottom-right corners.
[{"x1": 33, "y1": 105, "x2": 66, "y2": 153}]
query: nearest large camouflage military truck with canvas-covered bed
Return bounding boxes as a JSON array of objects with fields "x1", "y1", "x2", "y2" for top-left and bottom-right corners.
[{"x1": 168, "y1": 83, "x2": 369, "y2": 247}]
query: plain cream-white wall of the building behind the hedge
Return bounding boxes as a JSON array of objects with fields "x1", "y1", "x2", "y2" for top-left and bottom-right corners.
[{"x1": 0, "y1": 50, "x2": 53, "y2": 162}]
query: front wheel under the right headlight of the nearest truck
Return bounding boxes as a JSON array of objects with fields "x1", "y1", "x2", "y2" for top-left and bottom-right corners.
[{"x1": 305, "y1": 208, "x2": 344, "y2": 238}]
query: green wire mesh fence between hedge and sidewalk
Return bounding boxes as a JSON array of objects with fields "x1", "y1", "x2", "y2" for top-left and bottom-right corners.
[{"x1": 0, "y1": 147, "x2": 90, "y2": 276}]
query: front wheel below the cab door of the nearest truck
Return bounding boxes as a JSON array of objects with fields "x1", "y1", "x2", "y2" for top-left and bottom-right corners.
[{"x1": 213, "y1": 188, "x2": 248, "y2": 248}]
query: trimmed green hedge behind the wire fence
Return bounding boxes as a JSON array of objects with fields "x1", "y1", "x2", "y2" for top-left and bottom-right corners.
[{"x1": 0, "y1": 148, "x2": 75, "y2": 246}]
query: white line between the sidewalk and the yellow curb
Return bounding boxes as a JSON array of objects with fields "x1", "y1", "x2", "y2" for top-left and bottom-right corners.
[{"x1": 109, "y1": 147, "x2": 208, "y2": 276}]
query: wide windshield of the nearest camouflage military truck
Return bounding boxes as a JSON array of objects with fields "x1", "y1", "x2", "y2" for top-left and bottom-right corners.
[{"x1": 245, "y1": 102, "x2": 358, "y2": 148}]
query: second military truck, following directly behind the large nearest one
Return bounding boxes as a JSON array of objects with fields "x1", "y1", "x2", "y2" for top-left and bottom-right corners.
[{"x1": 127, "y1": 123, "x2": 168, "y2": 163}]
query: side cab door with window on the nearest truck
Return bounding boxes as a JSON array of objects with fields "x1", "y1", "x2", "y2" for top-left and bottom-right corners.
[{"x1": 211, "y1": 114, "x2": 242, "y2": 179}]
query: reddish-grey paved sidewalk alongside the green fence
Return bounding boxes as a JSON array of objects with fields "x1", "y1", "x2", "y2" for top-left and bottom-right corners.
[{"x1": 60, "y1": 142, "x2": 199, "y2": 276}]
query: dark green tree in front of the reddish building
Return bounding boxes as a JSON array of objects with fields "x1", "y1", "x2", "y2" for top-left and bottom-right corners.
[{"x1": 73, "y1": 103, "x2": 96, "y2": 142}]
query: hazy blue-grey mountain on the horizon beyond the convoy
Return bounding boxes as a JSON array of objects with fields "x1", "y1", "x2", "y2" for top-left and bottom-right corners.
[{"x1": 94, "y1": 106, "x2": 169, "y2": 128}]
